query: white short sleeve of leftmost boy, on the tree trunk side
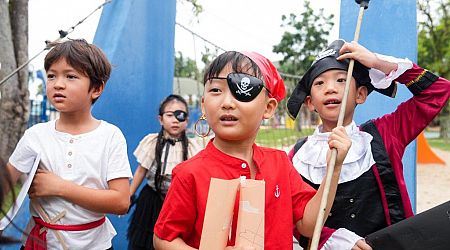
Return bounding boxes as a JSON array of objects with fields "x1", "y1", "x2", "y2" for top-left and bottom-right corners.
[{"x1": 9, "y1": 130, "x2": 38, "y2": 173}]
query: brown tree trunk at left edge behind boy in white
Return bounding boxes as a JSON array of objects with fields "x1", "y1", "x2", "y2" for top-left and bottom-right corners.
[{"x1": 0, "y1": 0, "x2": 29, "y2": 161}]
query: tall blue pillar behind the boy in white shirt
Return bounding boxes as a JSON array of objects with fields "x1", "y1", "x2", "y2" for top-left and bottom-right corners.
[{"x1": 93, "y1": 0, "x2": 176, "y2": 249}]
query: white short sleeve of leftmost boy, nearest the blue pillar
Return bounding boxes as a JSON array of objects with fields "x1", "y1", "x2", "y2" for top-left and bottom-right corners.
[{"x1": 106, "y1": 128, "x2": 133, "y2": 181}]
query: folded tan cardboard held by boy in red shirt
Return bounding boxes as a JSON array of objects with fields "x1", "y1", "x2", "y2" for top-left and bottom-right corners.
[{"x1": 199, "y1": 177, "x2": 265, "y2": 250}]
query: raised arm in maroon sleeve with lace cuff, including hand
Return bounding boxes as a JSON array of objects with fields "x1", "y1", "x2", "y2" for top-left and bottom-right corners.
[{"x1": 338, "y1": 42, "x2": 450, "y2": 147}]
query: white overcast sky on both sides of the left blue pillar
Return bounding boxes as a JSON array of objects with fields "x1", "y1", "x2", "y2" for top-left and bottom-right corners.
[{"x1": 29, "y1": 0, "x2": 340, "y2": 69}]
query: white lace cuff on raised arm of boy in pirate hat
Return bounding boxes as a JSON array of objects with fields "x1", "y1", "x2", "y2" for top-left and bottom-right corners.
[{"x1": 369, "y1": 53, "x2": 413, "y2": 89}]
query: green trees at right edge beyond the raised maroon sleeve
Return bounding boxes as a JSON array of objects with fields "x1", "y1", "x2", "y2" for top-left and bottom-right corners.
[{"x1": 418, "y1": 0, "x2": 450, "y2": 142}]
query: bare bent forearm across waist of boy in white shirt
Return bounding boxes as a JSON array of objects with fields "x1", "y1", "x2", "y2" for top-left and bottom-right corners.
[{"x1": 57, "y1": 178, "x2": 130, "y2": 214}]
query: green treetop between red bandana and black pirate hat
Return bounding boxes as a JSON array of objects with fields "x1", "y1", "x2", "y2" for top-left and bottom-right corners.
[{"x1": 273, "y1": 1, "x2": 334, "y2": 78}]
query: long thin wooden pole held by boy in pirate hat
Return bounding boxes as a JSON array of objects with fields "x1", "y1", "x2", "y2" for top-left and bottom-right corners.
[{"x1": 310, "y1": 4, "x2": 367, "y2": 250}]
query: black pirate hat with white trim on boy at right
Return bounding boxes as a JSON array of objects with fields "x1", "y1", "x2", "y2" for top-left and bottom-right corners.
[{"x1": 286, "y1": 39, "x2": 397, "y2": 119}]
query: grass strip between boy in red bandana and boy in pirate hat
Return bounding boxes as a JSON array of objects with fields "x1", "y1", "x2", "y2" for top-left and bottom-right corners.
[{"x1": 256, "y1": 128, "x2": 314, "y2": 148}]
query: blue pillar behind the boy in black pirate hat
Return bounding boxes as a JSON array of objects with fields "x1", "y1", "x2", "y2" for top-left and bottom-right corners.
[{"x1": 339, "y1": 0, "x2": 417, "y2": 211}]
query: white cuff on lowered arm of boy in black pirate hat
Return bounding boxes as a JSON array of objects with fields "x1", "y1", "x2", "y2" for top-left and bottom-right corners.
[{"x1": 321, "y1": 228, "x2": 363, "y2": 250}]
